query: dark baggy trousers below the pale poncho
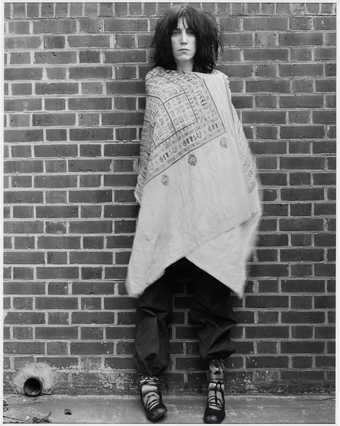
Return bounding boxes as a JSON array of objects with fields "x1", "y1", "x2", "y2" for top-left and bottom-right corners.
[{"x1": 135, "y1": 258, "x2": 235, "y2": 376}]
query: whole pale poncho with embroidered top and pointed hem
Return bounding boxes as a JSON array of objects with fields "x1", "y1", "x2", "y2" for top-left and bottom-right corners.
[{"x1": 126, "y1": 67, "x2": 261, "y2": 296}]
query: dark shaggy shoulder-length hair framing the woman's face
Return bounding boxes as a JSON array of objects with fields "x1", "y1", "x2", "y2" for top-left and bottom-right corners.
[{"x1": 151, "y1": 6, "x2": 222, "y2": 74}]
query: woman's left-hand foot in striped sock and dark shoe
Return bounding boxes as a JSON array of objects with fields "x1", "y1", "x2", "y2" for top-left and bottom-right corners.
[{"x1": 139, "y1": 376, "x2": 167, "y2": 423}]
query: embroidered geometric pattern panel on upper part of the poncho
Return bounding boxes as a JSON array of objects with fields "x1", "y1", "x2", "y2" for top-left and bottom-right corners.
[{"x1": 142, "y1": 73, "x2": 225, "y2": 183}]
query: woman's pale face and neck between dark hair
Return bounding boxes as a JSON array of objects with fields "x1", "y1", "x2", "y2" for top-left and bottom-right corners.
[{"x1": 171, "y1": 18, "x2": 196, "y2": 72}]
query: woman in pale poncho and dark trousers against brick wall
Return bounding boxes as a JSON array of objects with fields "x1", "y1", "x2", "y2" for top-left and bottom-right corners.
[{"x1": 126, "y1": 6, "x2": 261, "y2": 423}]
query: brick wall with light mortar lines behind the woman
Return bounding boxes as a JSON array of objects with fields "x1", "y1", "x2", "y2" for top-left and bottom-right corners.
[{"x1": 4, "y1": 2, "x2": 336, "y2": 393}]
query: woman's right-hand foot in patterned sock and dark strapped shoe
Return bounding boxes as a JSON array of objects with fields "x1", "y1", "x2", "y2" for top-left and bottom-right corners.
[{"x1": 203, "y1": 360, "x2": 225, "y2": 423}]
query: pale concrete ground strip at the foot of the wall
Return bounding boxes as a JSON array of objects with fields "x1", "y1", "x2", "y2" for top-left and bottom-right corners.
[{"x1": 3, "y1": 395, "x2": 335, "y2": 424}]
